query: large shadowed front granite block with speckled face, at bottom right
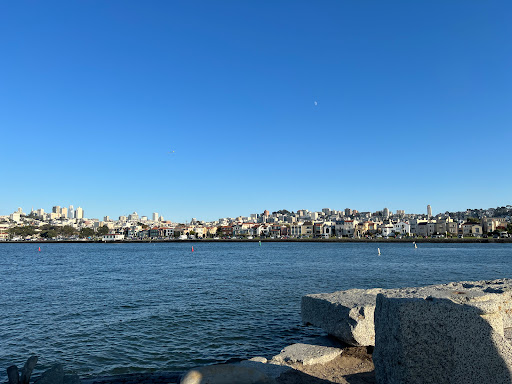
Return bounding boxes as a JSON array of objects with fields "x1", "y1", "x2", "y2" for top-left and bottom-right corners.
[{"x1": 373, "y1": 294, "x2": 512, "y2": 384}]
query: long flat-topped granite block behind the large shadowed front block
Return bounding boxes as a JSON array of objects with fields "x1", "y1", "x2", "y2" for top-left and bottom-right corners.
[{"x1": 301, "y1": 279, "x2": 512, "y2": 346}]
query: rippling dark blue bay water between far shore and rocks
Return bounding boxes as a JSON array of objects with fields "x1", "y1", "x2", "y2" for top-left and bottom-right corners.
[{"x1": 0, "y1": 242, "x2": 512, "y2": 376}]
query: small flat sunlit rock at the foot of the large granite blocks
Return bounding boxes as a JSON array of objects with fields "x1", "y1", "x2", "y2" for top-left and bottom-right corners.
[{"x1": 270, "y1": 344, "x2": 343, "y2": 365}]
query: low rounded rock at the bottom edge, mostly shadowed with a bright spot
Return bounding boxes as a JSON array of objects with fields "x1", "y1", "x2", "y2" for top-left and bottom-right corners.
[{"x1": 181, "y1": 364, "x2": 275, "y2": 384}]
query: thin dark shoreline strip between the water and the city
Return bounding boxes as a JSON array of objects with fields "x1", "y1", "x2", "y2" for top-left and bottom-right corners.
[{"x1": 0, "y1": 237, "x2": 512, "y2": 244}]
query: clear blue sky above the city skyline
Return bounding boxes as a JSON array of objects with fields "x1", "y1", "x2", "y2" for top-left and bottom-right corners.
[{"x1": 0, "y1": 0, "x2": 512, "y2": 221}]
